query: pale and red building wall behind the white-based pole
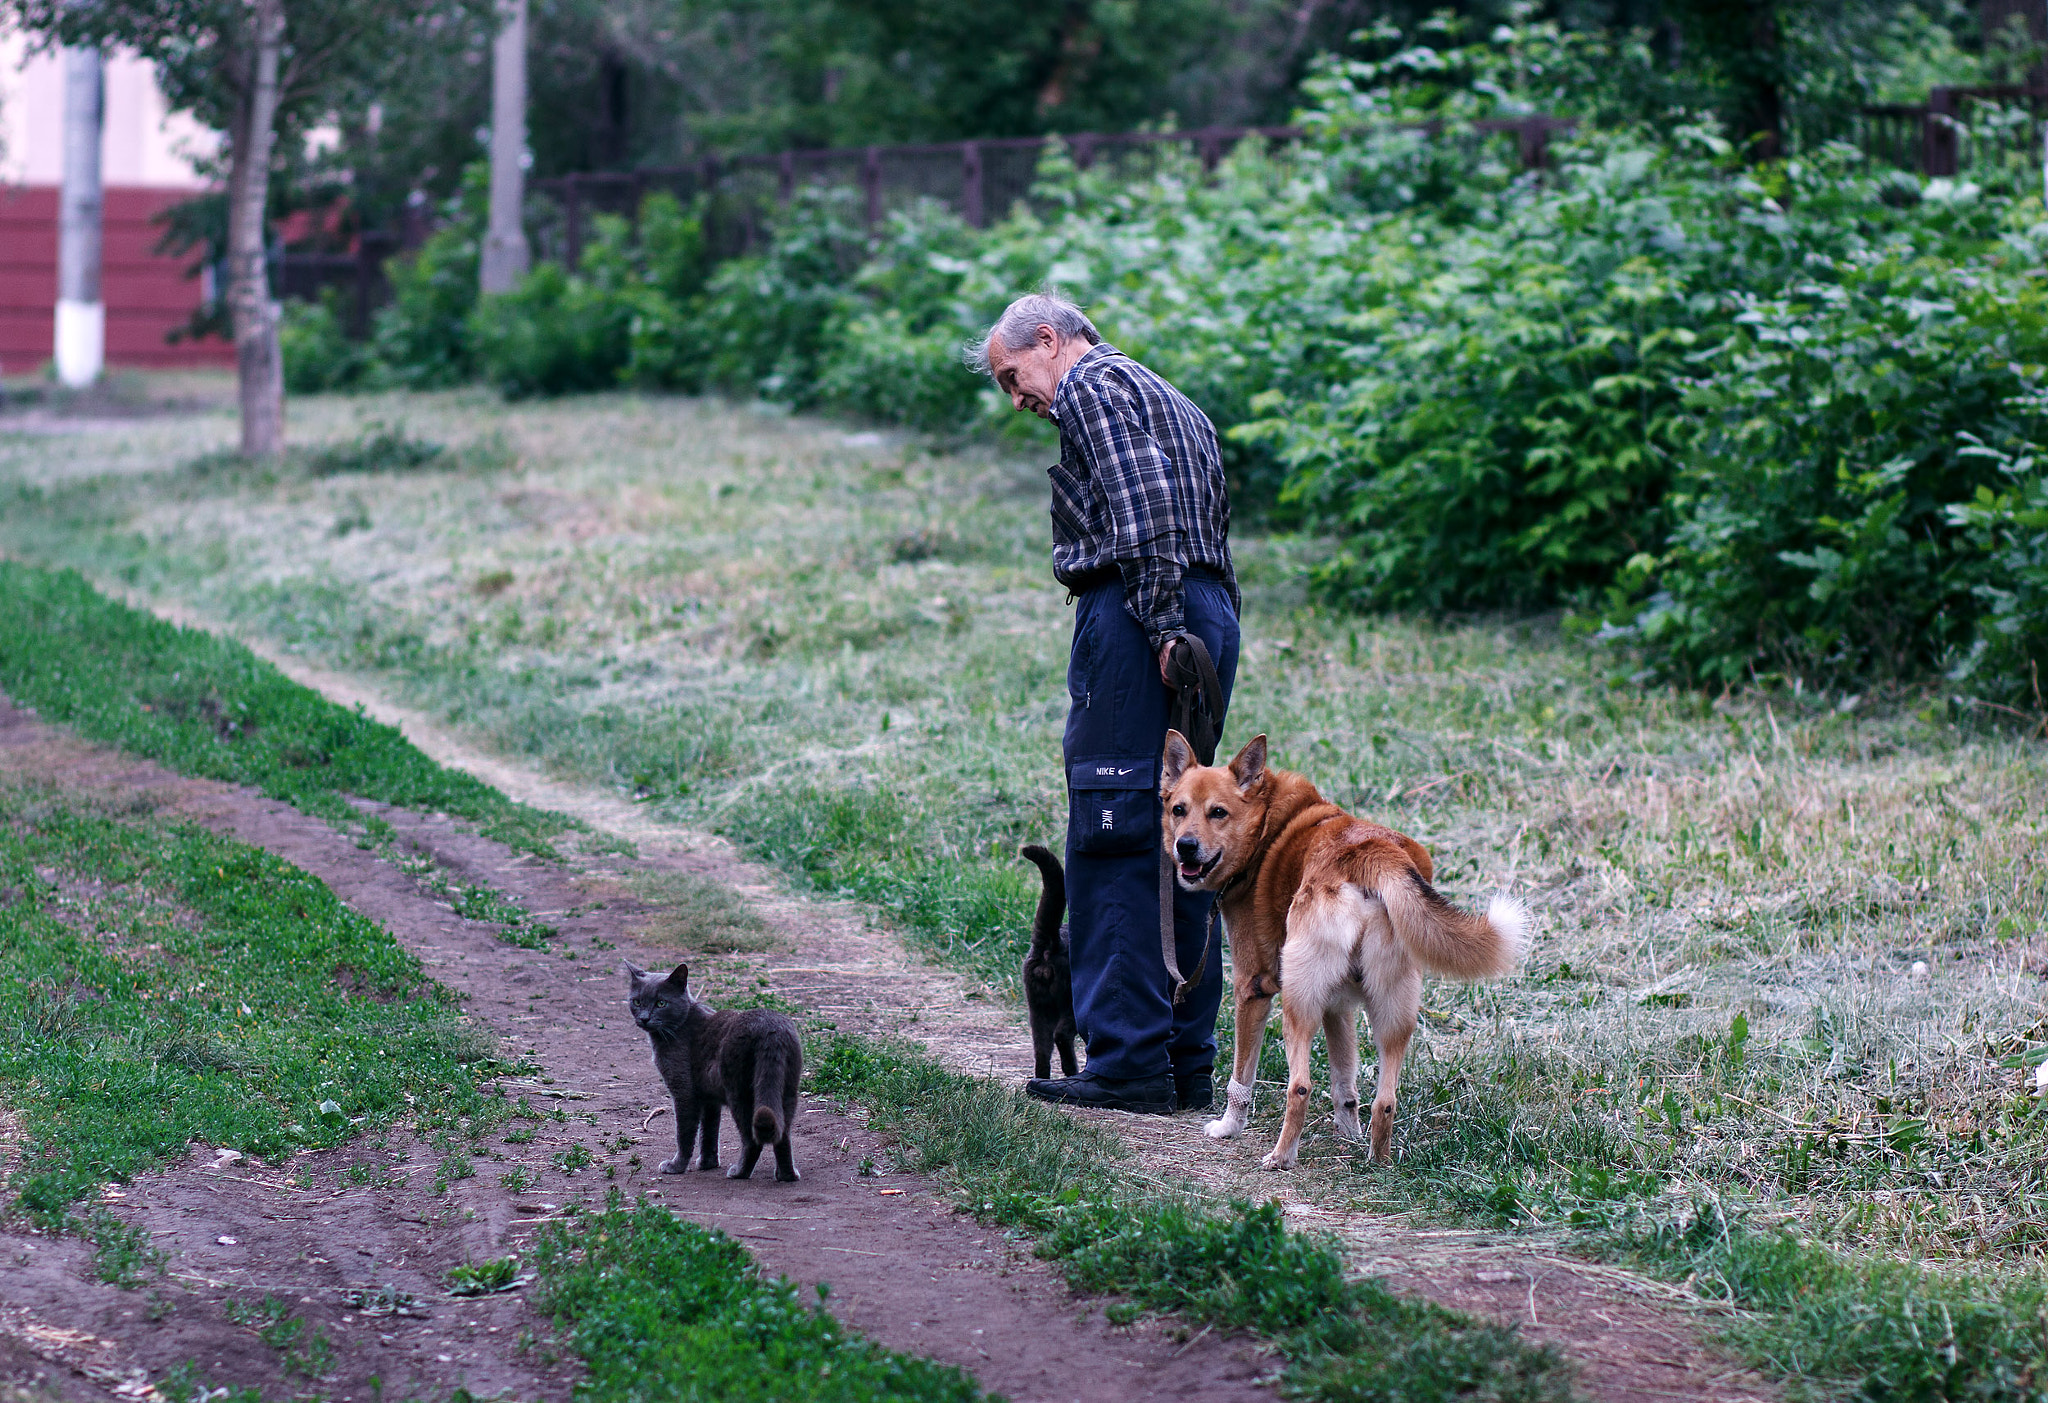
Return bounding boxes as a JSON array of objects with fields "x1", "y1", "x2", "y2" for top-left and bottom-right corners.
[{"x1": 0, "y1": 33, "x2": 233, "y2": 375}]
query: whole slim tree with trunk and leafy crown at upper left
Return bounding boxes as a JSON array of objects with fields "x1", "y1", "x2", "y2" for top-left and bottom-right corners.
[{"x1": 0, "y1": 0, "x2": 479, "y2": 459}]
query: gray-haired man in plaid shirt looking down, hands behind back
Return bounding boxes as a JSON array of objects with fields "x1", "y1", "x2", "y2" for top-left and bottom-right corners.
[{"x1": 981, "y1": 295, "x2": 1239, "y2": 1114}]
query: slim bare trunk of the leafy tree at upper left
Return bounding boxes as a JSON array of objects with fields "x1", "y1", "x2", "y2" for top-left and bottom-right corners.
[{"x1": 227, "y1": 0, "x2": 285, "y2": 459}]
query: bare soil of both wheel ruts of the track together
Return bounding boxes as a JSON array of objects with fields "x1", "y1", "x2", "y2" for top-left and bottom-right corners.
[{"x1": 0, "y1": 643, "x2": 1776, "y2": 1403}]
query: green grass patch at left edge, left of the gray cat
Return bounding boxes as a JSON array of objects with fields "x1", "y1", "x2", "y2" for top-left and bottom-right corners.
[{"x1": 0, "y1": 789, "x2": 504, "y2": 1220}]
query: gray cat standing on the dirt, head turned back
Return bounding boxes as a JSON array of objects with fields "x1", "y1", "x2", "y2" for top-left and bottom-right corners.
[{"x1": 627, "y1": 961, "x2": 803, "y2": 1180}]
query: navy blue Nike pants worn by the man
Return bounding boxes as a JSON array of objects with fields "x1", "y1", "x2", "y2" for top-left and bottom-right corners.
[{"x1": 1065, "y1": 578, "x2": 1237, "y2": 1081}]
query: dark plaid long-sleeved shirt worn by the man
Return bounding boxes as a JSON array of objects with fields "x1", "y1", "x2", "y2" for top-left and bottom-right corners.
[{"x1": 1047, "y1": 344, "x2": 1243, "y2": 651}]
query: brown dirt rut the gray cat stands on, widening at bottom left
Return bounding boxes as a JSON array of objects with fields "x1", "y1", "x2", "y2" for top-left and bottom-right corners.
[{"x1": 0, "y1": 703, "x2": 1272, "y2": 1403}]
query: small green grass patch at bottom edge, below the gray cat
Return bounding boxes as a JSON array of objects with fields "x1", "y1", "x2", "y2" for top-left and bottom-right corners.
[{"x1": 535, "y1": 1192, "x2": 983, "y2": 1403}]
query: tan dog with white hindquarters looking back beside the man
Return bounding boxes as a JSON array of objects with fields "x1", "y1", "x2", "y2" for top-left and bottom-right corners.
[{"x1": 1159, "y1": 731, "x2": 1524, "y2": 1170}]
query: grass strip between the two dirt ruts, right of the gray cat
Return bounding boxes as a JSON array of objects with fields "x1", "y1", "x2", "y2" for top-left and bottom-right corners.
[{"x1": 809, "y1": 1034, "x2": 1571, "y2": 1403}]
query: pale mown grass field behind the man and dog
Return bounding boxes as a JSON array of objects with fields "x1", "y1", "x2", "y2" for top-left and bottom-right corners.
[{"x1": 0, "y1": 380, "x2": 2048, "y2": 1376}]
